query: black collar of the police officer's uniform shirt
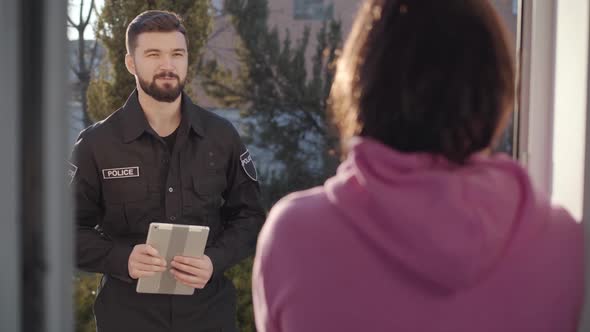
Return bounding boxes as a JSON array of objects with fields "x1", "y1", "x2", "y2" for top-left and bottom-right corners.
[{"x1": 122, "y1": 89, "x2": 205, "y2": 143}]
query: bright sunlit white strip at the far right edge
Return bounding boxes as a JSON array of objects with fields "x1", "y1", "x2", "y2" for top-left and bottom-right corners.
[{"x1": 552, "y1": 0, "x2": 589, "y2": 220}]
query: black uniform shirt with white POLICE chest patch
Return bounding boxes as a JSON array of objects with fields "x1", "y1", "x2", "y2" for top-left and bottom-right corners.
[{"x1": 70, "y1": 91, "x2": 264, "y2": 282}]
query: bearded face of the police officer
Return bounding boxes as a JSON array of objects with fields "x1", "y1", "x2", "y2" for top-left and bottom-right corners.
[{"x1": 127, "y1": 31, "x2": 188, "y2": 103}]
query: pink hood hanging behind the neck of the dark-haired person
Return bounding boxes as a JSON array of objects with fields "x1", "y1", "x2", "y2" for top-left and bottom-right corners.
[{"x1": 325, "y1": 138, "x2": 535, "y2": 290}]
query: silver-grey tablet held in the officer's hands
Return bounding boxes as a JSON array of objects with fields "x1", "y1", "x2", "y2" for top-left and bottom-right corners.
[{"x1": 136, "y1": 223, "x2": 209, "y2": 295}]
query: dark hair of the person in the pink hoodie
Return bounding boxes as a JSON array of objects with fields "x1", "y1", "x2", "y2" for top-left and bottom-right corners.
[{"x1": 329, "y1": 0, "x2": 515, "y2": 164}]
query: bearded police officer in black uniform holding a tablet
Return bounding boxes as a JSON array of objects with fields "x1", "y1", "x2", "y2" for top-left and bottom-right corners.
[{"x1": 69, "y1": 11, "x2": 264, "y2": 332}]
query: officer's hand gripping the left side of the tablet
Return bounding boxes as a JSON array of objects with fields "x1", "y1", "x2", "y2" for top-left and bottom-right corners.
[{"x1": 127, "y1": 244, "x2": 166, "y2": 279}]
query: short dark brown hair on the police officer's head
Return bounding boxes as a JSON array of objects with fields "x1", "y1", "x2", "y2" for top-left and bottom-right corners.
[{"x1": 125, "y1": 10, "x2": 188, "y2": 54}]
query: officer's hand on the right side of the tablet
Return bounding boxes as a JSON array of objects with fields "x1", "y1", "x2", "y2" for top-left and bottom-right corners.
[{"x1": 170, "y1": 255, "x2": 213, "y2": 289}]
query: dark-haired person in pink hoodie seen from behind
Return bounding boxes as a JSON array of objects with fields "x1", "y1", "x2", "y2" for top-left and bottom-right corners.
[{"x1": 253, "y1": 0, "x2": 583, "y2": 332}]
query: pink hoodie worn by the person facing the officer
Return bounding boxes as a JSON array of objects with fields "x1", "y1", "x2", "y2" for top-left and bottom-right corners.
[{"x1": 253, "y1": 139, "x2": 583, "y2": 332}]
